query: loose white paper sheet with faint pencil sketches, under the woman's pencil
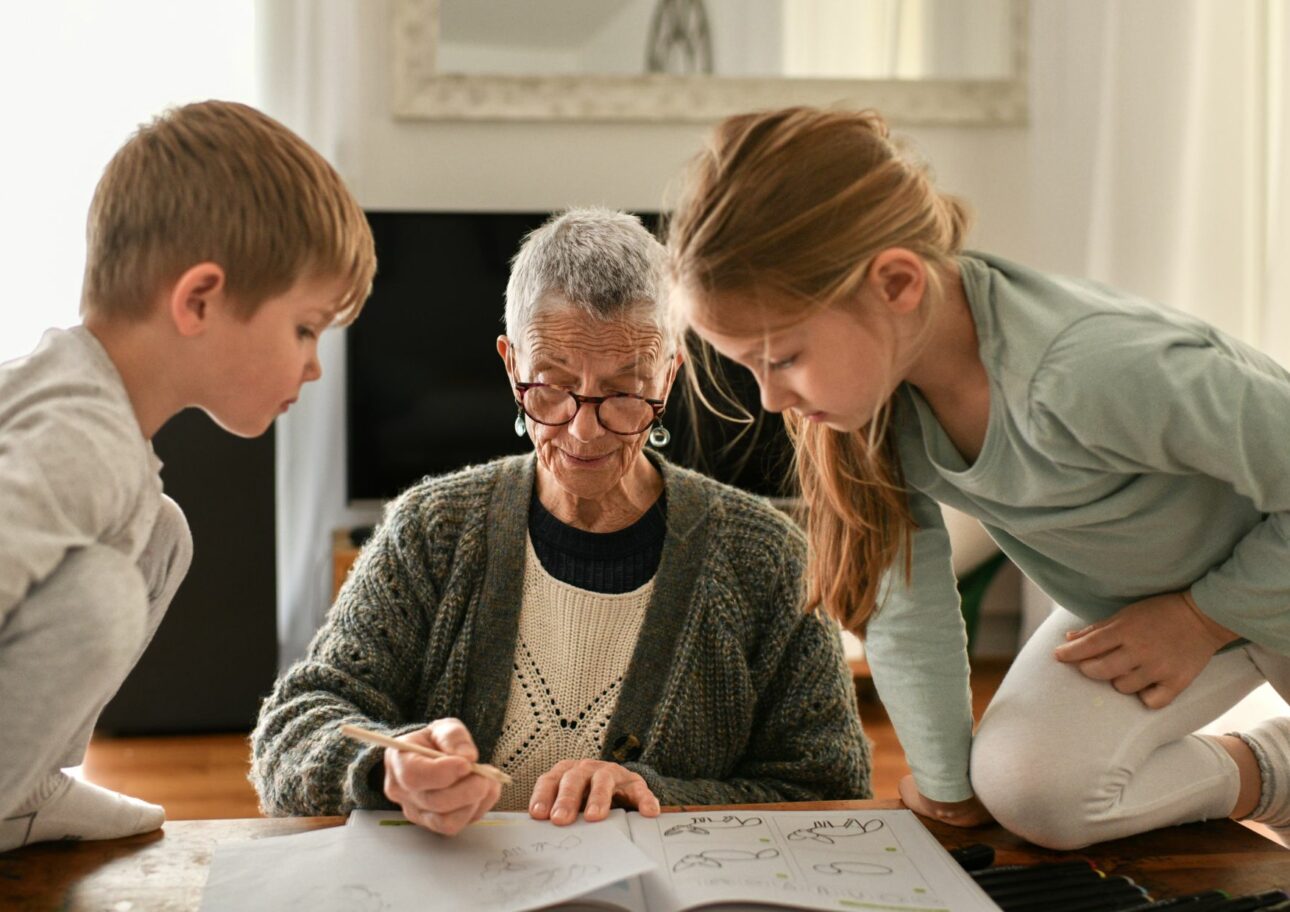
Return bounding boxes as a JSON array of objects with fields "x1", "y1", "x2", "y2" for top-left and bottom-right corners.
[{"x1": 201, "y1": 811, "x2": 653, "y2": 912}]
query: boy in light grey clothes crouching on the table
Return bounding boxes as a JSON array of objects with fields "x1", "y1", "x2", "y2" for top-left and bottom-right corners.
[{"x1": 0, "y1": 102, "x2": 375, "y2": 851}]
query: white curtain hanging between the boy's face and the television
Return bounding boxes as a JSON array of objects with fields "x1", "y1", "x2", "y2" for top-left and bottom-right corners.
[{"x1": 257, "y1": 0, "x2": 373, "y2": 667}]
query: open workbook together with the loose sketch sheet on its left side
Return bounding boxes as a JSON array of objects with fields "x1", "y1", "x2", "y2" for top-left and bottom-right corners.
[{"x1": 201, "y1": 810, "x2": 997, "y2": 912}]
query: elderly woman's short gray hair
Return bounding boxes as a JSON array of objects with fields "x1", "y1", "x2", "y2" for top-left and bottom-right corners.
[{"x1": 506, "y1": 208, "x2": 672, "y2": 347}]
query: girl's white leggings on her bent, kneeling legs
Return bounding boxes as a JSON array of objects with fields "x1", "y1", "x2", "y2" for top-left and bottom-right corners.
[{"x1": 971, "y1": 608, "x2": 1290, "y2": 849}]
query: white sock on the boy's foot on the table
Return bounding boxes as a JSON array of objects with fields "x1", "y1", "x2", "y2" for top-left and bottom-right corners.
[{"x1": 0, "y1": 771, "x2": 165, "y2": 851}]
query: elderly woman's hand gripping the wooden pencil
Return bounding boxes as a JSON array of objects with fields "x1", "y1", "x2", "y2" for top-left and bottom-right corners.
[{"x1": 386, "y1": 719, "x2": 502, "y2": 836}]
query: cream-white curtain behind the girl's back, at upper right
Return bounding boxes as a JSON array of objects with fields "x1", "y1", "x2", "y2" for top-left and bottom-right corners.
[{"x1": 1026, "y1": 0, "x2": 1290, "y2": 728}]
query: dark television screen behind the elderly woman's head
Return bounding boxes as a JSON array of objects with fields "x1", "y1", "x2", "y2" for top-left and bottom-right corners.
[{"x1": 346, "y1": 212, "x2": 788, "y2": 501}]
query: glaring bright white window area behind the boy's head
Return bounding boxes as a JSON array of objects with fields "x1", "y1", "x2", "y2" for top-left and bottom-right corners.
[{"x1": 0, "y1": 0, "x2": 258, "y2": 361}]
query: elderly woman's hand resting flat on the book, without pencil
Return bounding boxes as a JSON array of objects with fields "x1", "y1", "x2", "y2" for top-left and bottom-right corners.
[{"x1": 529, "y1": 760, "x2": 658, "y2": 826}]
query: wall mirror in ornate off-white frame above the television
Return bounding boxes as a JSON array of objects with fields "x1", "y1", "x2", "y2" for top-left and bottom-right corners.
[{"x1": 395, "y1": 0, "x2": 1028, "y2": 124}]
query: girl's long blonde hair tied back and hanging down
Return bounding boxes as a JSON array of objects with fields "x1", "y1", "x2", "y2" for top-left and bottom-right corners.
[{"x1": 667, "y1": 107, "x2": 969, "y2": 632}]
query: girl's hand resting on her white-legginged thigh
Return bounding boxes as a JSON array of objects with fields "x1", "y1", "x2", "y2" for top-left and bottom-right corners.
[{"x1": 1054, "y1": 592, "x2": 1236, "y2": 709}]
